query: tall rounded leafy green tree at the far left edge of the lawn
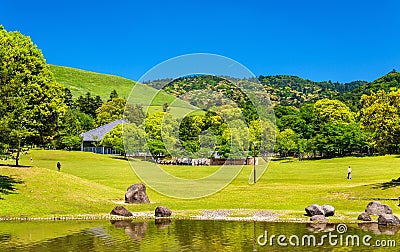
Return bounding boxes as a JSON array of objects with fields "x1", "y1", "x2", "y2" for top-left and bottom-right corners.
[{"x1": 0, "y1": 26, "x2": 66, "y2": 165}]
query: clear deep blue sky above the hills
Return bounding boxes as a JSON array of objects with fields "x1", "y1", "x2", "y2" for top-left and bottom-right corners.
[{"x1": 0, "y1": 0, "x2": 400, "y2": 82}]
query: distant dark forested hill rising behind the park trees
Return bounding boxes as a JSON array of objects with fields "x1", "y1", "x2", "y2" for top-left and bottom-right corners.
[{"x1": 145, "y1": 72, "x2": 400, "y2": 112}]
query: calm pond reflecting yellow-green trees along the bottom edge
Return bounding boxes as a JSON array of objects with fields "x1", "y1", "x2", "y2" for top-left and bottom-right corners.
[{"x1": 0, "y1": 219, "x2": 400, "y2": 252}]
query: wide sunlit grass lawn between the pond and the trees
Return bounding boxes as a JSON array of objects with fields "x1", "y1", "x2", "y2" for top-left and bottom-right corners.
[{"x1": 0, "y1": 150, "x2": 400, "y2": 220}]
